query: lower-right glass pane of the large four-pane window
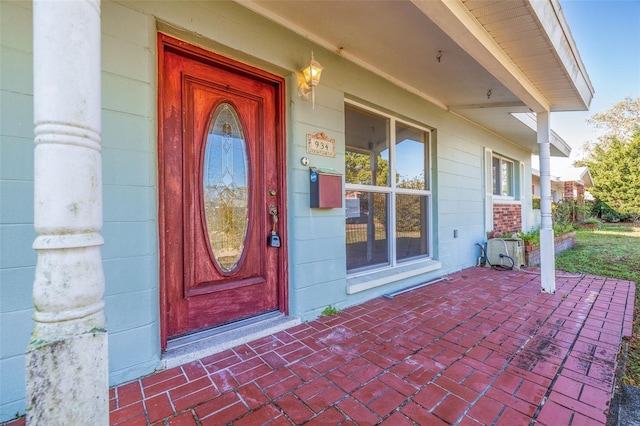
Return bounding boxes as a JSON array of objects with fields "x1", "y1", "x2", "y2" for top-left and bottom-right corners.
[{"x1": 396, "y1": 194, "x2": 429, "y2": 260}]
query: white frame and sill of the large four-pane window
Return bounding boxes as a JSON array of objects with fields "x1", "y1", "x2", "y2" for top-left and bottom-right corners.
[{"x1": 345, "y1": 99, "x2": 442, "y2": 280}]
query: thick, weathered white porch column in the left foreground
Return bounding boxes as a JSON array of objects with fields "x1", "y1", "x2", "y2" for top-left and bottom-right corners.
[{"x1": 26, "y1": 0, "x2": 109, "y2": 425}]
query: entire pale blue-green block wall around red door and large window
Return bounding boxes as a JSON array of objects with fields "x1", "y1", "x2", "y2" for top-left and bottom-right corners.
[{"x1": 0, "y1": 1, "x2": 530, "y2": 421}]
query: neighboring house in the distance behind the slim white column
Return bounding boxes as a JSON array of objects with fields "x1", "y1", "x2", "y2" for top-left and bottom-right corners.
[{"x1": 531, "y1": 167, "x2": 593, "y2": 203}]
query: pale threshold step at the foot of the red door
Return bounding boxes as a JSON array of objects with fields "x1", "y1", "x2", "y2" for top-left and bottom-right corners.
[{"x1": 160, "y1": 311, "x2": 301, "y2": 370}]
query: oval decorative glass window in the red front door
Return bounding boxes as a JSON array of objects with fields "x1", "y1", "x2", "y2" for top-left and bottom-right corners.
[{"x1": 202, "y1": 103, "x2": 249, "y2": 272}]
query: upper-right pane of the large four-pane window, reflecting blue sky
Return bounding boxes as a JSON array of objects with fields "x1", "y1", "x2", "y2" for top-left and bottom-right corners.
[{"x1": 396, "y1": 123, "x2": 427, "y2": 189}]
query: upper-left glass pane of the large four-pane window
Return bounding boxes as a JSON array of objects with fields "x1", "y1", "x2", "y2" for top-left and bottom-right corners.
[{"x1": 345, "y1": 105, "x2": 389, "y2": 186}]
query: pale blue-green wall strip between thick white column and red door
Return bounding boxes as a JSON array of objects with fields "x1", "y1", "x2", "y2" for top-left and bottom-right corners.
[{"x1": 102, "y1": 2, "x2": 160, "y2": 384}]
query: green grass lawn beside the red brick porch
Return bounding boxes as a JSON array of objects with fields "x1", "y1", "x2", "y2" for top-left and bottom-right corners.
[{"x1": 556, "y1": 224, "x2": 640, "y2": 386}]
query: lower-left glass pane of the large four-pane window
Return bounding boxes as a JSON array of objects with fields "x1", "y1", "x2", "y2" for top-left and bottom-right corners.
[{"x1": 345, "y1": 191, "x2": 389, "y2": 271}]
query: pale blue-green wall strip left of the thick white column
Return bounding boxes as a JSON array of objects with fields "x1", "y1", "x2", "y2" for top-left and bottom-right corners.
[{"x1": 0, "y1": 1, "x2": 36, "y2": 421}]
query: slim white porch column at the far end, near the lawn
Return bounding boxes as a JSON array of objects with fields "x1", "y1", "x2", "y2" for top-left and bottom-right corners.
[{"x1": 537, "y1": 112, "x2": 556, "y2": 294}]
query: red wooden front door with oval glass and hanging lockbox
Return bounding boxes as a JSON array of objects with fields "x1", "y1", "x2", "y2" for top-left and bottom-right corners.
[{"x1": 158, "y1": 35, "x2": 286, "y2": 346}]
